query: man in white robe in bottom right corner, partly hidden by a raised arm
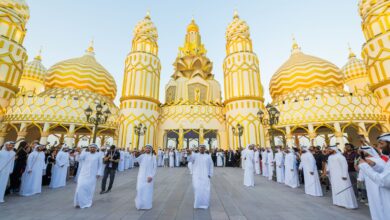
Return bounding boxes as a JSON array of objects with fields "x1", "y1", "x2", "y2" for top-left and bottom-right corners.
[{"x1": 358, "y1": 146, "x2": 386, "y2": 220}]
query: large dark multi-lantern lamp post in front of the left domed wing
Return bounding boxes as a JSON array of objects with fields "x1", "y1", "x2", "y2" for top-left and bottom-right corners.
[{"x1": 84, "y1": 103, "x2": 111, "y2": 143}]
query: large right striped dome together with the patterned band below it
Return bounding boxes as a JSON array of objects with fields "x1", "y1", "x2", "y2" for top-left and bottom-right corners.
[{"x1": 270, "y1": 38, "x2": 384, "y2": 125}]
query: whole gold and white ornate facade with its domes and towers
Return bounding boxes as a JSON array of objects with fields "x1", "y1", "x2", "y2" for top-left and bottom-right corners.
[{"x1": 0, "y1": 0, "x2": 390, "y2": 149}]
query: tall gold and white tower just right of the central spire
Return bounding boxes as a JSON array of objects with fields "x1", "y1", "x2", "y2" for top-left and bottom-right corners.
[{"x1": 223, "y1": 12, "x2": 266, "y2": 148}]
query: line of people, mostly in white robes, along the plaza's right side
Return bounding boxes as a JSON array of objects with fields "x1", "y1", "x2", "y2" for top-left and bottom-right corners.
[{"x1": 241, "y1": 133, "x2": 390, "y2": 220}]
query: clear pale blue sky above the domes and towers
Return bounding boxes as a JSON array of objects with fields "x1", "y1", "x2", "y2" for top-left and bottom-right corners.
[{"x1": 24, "y1": 0, "x2": 364, "y2": 103}]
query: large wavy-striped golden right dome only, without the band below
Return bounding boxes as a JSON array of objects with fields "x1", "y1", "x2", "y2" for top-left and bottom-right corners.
[{"x1": 270, "y1": 39, "x2": 343, "y2": 98}]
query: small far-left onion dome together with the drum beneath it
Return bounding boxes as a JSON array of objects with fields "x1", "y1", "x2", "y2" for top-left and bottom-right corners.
[{"x1": 19, "y1": 52, "x2": 47, "y2": 93}]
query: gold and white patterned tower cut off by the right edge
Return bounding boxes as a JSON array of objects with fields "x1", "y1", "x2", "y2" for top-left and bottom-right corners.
[{"x1": 359, "y1": 0, "x2": 390, "y2": 114}]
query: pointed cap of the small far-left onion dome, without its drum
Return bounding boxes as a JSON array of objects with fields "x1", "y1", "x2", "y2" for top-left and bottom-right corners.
[{"x1": 22, "y1": 51, "x2": 47, "y2": 83}]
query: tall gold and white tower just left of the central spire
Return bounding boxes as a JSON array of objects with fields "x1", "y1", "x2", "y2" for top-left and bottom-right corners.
[{"x1": 118, "y1": 13, "x2": 161, "y2": 148}]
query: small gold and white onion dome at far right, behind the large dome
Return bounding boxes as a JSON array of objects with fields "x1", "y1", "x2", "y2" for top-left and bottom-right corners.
[{"x1": 341, "y1": 48, "x2": 368, "y2": 81}]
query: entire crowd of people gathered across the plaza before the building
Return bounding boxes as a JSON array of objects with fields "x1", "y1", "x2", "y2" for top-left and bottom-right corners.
[{"x1": 0, "y1": 133, "x2": 390, "y2": 220}]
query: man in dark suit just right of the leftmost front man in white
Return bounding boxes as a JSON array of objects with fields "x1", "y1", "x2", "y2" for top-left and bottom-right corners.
[{"x1": 100, "y1": 145, "x2": 120, "y2": 194}]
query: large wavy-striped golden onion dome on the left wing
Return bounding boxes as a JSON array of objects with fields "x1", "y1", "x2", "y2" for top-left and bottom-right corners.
[{"x1": 45, "y1": 43, "x2": 117, "y2": 100}]
